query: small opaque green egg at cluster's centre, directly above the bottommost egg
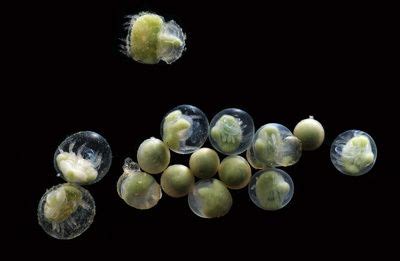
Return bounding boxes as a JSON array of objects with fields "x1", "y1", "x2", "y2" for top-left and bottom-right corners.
[{"x1": 189, "y1": 148, "x2": 220, "y2": 179}]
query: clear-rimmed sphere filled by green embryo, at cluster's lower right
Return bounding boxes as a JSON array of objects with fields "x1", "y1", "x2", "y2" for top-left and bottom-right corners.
[{"x1": 249, "y1": 168, "x2": 294, "y2": 210}]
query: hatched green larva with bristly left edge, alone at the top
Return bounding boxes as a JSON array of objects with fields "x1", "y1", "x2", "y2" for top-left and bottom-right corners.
[{"x1": 124, "y1": 12, "x2": 186, "y2": 64}]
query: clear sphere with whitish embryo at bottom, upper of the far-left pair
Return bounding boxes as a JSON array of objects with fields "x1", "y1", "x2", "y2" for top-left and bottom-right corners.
[{"x1": 54, "y1": 131, "x2": 112, "y2": 185}]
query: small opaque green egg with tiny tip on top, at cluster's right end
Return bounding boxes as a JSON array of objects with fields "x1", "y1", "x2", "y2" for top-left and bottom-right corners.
[{"x1": 293, "y1": 116, "x2": 325, "y2": 150}]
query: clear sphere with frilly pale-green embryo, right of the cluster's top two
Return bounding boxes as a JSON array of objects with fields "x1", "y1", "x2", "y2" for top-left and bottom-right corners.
[{"x1": 209, "y1": 108, "x2": 254, "y2": 155}]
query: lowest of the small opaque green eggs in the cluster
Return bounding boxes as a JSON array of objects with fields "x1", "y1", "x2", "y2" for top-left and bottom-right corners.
[{"x1": 161, "y1": 164, "x2": 194, "y2": 198}]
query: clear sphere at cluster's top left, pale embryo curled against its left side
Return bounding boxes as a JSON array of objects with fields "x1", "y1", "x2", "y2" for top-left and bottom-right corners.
[{"x1": 161, "y1": 105, "x2": 209, "y2": 154}]
